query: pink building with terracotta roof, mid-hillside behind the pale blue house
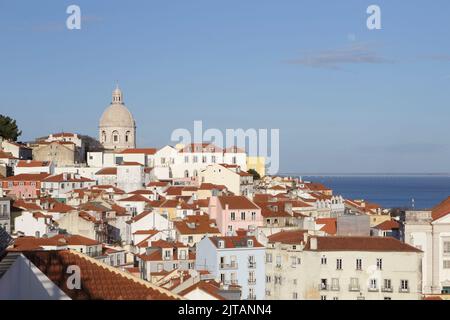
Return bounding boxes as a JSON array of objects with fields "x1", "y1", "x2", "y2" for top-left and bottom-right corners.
[{"x1": 208, "y1": 196, "x2": 263, "y2": 235}]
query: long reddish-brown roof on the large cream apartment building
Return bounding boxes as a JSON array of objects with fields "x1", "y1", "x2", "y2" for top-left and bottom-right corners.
[{"x1": 307, "y1": 236, "x2": 422, "y2": 252}]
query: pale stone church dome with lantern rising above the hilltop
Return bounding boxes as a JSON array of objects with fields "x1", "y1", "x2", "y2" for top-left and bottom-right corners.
[{"x1": 99, "y1": 87, "x2": 136, "y2": 151}]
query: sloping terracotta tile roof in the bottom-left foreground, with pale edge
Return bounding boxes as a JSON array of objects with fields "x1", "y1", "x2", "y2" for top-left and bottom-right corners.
[{"x1": 18, "y1": 250, "x2": 180, "y2": 300}]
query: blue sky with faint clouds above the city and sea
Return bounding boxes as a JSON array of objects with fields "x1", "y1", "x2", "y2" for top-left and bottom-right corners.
[{"x1": 0, "y1": 0, "x2": 450, "y2": 173}]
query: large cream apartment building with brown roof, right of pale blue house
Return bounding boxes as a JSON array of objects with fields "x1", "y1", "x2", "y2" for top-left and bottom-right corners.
[{"x1": 265, "y1": 230, "x2": 422, "y2": 300}]
